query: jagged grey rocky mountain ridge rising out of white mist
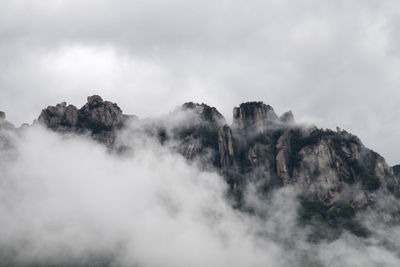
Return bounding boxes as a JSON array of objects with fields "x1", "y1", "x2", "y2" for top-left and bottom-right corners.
[{"x1": 0, "y1": 95, "x2": 400, "y2": 242}]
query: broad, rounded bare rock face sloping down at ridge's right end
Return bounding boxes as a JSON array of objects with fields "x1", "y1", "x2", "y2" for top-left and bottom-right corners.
[{"x1": 276, "y1": 130, "x2": 399, "y2": 208}]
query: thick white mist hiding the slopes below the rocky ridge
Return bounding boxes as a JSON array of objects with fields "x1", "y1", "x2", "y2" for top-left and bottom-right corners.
[{"x1": 0, "y1": 126, "x2": 400, "y2": 267}]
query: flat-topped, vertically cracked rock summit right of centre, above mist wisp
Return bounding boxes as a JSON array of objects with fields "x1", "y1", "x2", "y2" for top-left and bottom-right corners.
[{"x1": 233, "y1": 102, "x2": 278, "y2": 134}]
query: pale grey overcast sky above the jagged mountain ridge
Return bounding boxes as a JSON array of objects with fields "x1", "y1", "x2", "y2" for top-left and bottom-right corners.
[{"x1": 0, "y1": 0, "x2": 400, "y2": 164}]
